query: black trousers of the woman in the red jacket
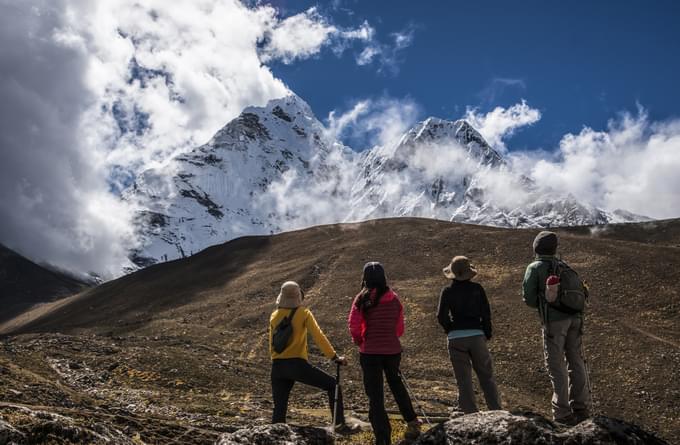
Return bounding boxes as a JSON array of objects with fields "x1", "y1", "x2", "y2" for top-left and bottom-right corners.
[{"x1": 360, "y1": 354, "x2": 417, "y2": 445}]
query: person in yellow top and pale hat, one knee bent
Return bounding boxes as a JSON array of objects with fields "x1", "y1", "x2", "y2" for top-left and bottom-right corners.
[{"x1": 269, "y1": 281, "x2": 352, "y2": 432}]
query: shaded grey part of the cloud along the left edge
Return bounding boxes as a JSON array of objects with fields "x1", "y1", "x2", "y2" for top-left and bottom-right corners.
[{"x1": 0, "y1": 1, "x2": 138, "y2": 274}]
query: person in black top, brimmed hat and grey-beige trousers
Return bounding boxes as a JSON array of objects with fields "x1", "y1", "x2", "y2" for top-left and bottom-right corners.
[{"x1": 437, "y1": 256, "x2": 501, "y2": 414}]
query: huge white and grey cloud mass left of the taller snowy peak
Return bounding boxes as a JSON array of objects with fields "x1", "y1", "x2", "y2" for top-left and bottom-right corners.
[{"x1": 0, "y1": 0, "x2": 374, "y2": 276}]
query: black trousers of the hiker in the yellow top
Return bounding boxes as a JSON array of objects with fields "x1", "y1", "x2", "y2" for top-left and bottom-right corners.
[{"x1": 272, "y1": 358, "x2": 345, "y2": 424}]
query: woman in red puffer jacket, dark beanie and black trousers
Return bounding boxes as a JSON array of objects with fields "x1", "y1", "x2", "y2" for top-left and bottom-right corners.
[{"x1": 348, "y1": 262, "x2": 420, "y2": 445}]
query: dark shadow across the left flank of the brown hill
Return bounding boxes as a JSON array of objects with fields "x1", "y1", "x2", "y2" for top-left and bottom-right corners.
[{"x1": 11, "y1": 236, "x2": 271, "y2": 334}]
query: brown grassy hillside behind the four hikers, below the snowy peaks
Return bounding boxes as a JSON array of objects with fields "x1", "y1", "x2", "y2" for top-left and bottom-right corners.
[{"x1": 0, "y1": 218, "x2": 680, "y2": 443}]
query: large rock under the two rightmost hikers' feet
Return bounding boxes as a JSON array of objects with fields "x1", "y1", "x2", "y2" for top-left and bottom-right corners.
[{"x1": 414, "y1": 411, "x2": 667, "y2": 445}]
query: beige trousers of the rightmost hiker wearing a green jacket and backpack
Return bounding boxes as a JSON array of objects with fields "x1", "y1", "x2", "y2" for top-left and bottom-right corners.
[{"x1": 543, "y1": 317, "x2": 591, "y2": 420}]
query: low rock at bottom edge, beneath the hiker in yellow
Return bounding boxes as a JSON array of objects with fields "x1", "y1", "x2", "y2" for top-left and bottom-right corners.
[{"x1": 216, "y1": 423, "x2": 333, "y2": 445}]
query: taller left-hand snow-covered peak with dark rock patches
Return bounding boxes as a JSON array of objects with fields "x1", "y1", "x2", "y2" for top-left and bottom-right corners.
[{"x1": 125, "y1": 96, "x2": 347, "y2": 266}]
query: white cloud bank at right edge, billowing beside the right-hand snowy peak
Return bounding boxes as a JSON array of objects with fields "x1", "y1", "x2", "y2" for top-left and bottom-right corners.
[{"x1": 464, "y1": 101, "x2": 680, "y2": 218}]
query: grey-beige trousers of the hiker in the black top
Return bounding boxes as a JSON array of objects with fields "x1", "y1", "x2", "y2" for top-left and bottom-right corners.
[{"x1": 449, "y1": 335, "x2": 501, "y2": 413}]
